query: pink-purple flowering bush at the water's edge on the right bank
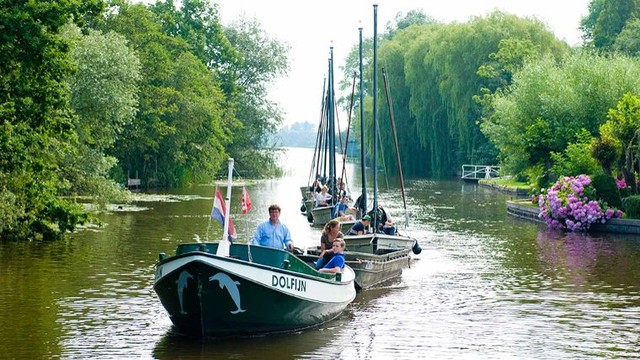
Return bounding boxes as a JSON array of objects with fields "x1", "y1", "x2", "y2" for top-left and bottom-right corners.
[{"x1": 538, "y1": 175, "x2": 622, "y2": 231}]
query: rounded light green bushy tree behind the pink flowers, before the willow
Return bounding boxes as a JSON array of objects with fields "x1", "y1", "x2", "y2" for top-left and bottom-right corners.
[{"x1": 481, "y1": 52, "x2": 640, "y2": 181}]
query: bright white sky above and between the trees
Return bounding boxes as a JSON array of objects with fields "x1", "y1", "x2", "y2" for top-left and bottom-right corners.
[{"x1": 213, "y1": 0, "x2": 590, "y2": 125}]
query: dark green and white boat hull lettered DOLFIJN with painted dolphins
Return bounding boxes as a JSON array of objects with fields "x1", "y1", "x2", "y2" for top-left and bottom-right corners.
[{"x1": 153, "y1": 243, "x2": 356, "y2": 337}]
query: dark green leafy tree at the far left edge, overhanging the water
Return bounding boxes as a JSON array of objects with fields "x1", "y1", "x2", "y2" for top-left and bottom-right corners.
[{"x1": 0, "y1": 0, "x2": 103, "y2": 240}]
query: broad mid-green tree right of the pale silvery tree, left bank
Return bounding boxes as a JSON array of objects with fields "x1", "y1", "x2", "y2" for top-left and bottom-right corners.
[{"x1": 100, "y1": 2, "x2": 236, "y2": 186}]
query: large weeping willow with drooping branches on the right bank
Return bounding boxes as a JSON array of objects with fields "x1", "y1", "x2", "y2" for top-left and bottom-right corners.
[{"x1": 397, "y1": 12, "x2": 565, "y2": 177}]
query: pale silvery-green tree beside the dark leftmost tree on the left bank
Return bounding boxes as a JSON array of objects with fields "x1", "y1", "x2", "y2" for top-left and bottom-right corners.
[{"x1": 63, "y1": 26, "x2": 140, "y2": 204}]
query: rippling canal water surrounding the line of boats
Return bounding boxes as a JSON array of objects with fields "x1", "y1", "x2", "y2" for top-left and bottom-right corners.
[{"x1": 0, "y1": 149, "x2": 640, "y2": 359}]
